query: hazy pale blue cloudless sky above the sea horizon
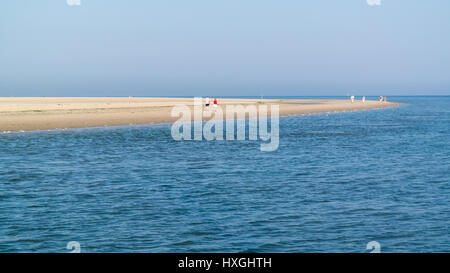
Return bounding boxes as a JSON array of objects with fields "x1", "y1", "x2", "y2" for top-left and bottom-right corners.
[{"x1": 0, "y1": 0, "x2": 450, "y2": 96}]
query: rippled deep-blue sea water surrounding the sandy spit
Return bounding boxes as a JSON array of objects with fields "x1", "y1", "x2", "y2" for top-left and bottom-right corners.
[{"x1": 0, "y1": 96, "x2": 450, "y2": 252}]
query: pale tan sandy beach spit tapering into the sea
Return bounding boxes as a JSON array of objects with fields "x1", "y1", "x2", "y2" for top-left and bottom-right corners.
[{"x1": 0, "y1": 97, "x2": 398, "y2": 132}]
